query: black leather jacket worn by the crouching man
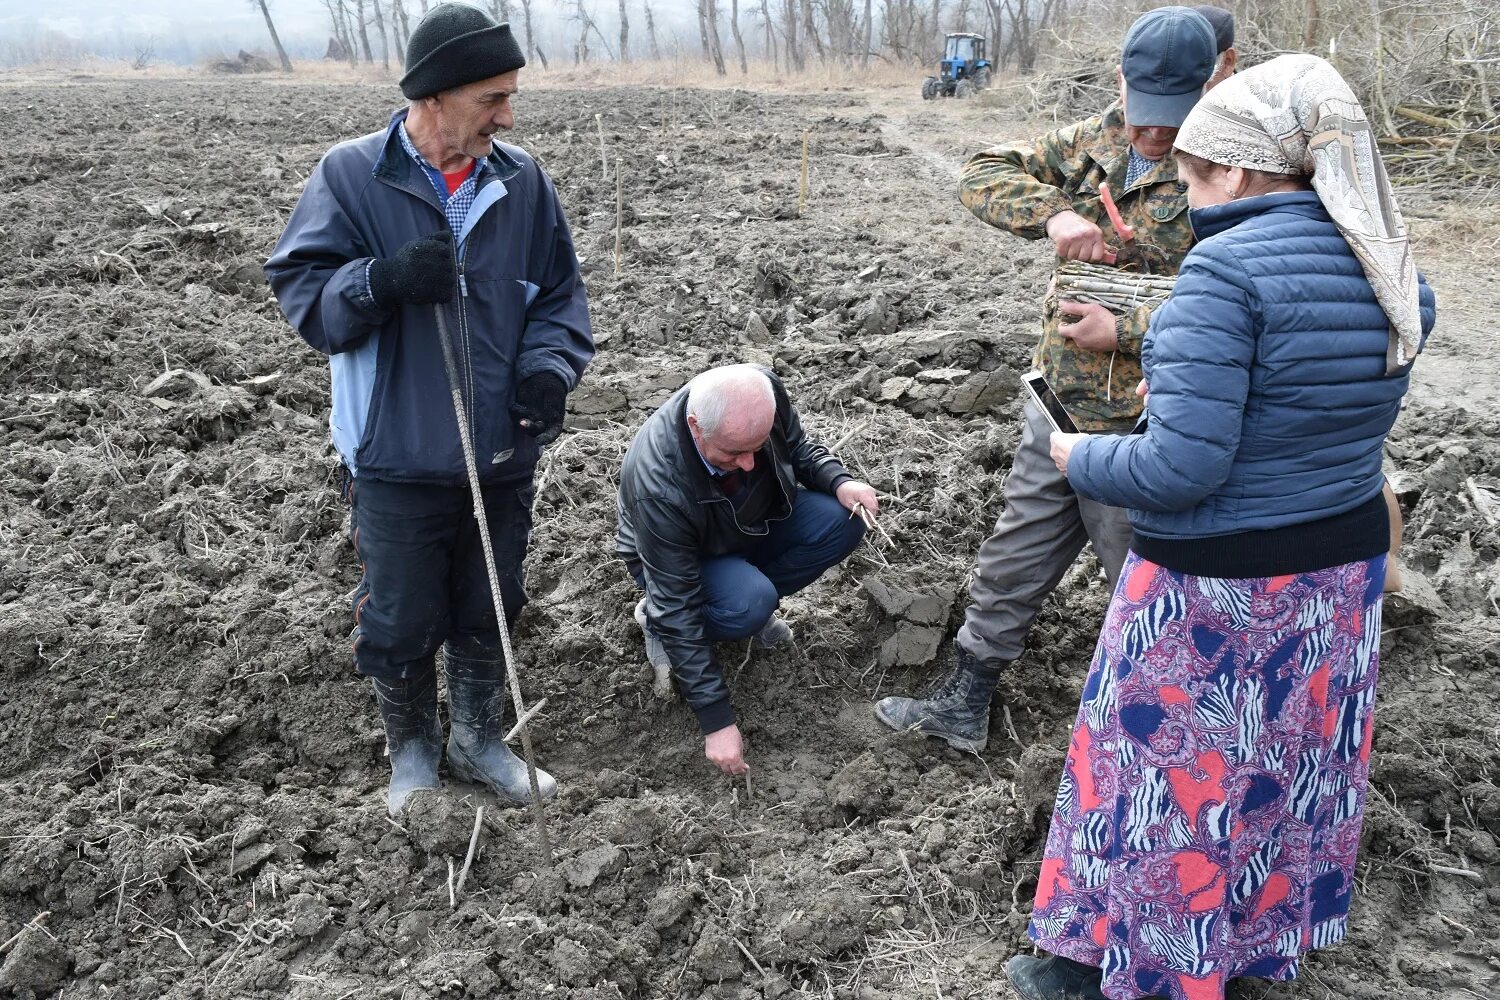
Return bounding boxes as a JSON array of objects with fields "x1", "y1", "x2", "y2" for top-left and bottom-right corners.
[{"x1": 615, "y1": 370, "x2": 854, "y2": 733}]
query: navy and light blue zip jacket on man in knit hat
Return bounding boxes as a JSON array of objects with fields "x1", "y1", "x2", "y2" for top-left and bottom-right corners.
[{"x1": 266, "y1": 111, "x2": 594, "y2": 484}]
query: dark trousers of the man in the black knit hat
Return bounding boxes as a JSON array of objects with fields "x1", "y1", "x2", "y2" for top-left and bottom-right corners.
[{"x1": 351, "y1": 480, "x2": 534, "y2": 681}]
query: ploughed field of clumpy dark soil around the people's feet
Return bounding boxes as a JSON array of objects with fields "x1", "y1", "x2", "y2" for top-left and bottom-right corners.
[{"x1": 0, "y1": 81, "x2": 1500, "y2": 1000}]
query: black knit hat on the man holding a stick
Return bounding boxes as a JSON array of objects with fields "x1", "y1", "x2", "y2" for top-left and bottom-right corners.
[{"x1": 401, "y1": 3, "x2": 527, "y2": 100}]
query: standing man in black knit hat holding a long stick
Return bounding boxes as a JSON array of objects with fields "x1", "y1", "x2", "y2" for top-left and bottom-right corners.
[{"x1": 266, "y1": 3, "x2": 594, "y2": 816}]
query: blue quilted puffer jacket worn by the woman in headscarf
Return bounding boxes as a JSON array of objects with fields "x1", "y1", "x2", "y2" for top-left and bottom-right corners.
[{"x1": 1068, "y1": 192, "x2": 1434, "y2": 538}]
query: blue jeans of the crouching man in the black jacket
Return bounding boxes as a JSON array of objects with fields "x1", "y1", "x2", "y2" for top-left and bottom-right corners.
[{"x1": 635, "y1": 489, "x2": 864, "y2": 642}]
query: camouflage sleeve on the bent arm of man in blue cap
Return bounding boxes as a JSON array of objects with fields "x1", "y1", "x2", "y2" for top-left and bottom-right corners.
[{"x1": 959, "y1": 123, "x2": 1082, "y2": 240}]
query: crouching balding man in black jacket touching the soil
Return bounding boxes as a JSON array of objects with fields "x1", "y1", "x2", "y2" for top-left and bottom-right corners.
[{"x1": 615, "y1": 364, "x2": 881, "y2": 775}]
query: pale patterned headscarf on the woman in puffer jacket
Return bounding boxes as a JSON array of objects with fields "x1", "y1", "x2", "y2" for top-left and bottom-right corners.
[{"x1": 1176, "y1": 55, "x2": 1422, "y2": 373}]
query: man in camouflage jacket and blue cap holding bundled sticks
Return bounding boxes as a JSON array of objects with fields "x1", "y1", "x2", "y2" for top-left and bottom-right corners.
[{"x1": 875, "y1": 7, "x2": 1217, "y2": 751}]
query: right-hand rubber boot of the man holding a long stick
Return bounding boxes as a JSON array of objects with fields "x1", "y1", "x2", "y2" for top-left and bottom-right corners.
[{"x1": 443, "y1": 646, "x2": 558, "y2": 804}]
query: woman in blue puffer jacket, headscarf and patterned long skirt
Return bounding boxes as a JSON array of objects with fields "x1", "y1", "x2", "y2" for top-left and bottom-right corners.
[{"x1": 1008, "y1": 55, "x2": 1434, "y2": 1000}]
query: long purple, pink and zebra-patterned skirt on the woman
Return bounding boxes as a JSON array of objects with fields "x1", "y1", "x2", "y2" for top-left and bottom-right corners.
[{"x1": 1029, "y1": 552, "x2": 1385, "y2": 1000}]
